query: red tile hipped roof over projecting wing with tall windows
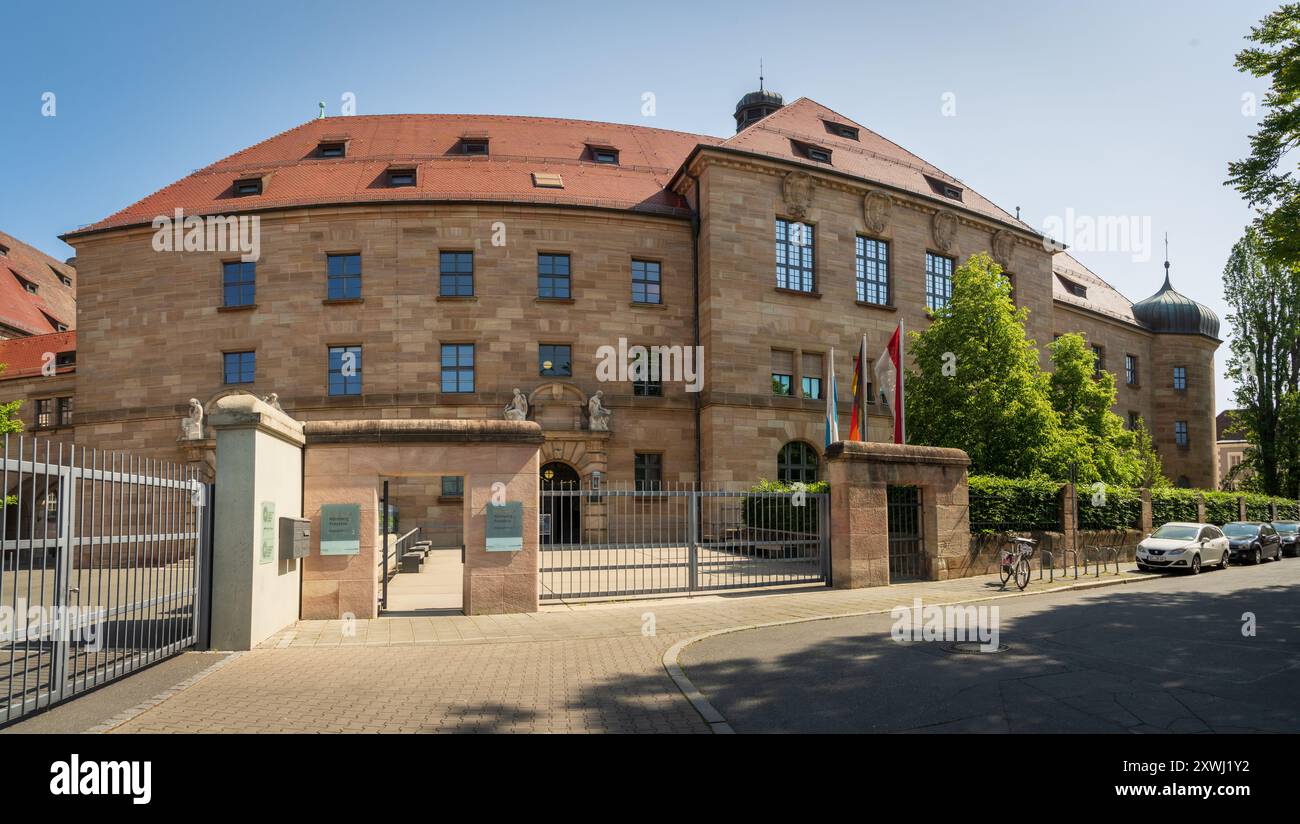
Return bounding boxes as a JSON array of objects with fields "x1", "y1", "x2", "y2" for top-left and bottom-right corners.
[{"x1": 723, "y1": 97, "x2": 1040, "y2": 235}]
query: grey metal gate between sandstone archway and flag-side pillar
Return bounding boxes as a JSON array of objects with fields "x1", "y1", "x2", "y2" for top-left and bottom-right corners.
[{"x1": 538, "y1": 483, "x2": 831, "y2": 600}]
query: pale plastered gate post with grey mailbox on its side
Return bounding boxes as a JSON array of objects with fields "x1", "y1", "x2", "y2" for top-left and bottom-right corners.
[{"x1": 208, "y1": 394, "x2": 303, "y2": 650}]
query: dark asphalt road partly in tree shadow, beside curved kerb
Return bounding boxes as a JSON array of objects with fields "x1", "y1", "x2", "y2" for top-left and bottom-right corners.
[{"x1": 681, "y1": 559, "x2": 1300, "y2": 733}]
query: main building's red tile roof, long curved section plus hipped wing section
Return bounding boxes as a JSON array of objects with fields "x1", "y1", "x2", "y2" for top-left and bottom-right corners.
[{"x1": 65, "y1": 97, "x2": 1037, "y2": 238}]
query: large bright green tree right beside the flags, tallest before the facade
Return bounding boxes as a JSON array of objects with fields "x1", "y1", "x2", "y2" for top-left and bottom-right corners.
[{"x1": 907, "y1": 253, "x2": 1057, "y2": 477}]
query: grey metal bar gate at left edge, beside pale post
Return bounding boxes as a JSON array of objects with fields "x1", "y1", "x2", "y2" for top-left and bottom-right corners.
[{"x1": 0, "y1": 435, "x2": 212, "y2": 724}]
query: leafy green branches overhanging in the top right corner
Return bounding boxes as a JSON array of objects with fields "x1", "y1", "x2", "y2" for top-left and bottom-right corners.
[{"x1": 1226, "y1": 3, "x2": 1300, "y2": 261}]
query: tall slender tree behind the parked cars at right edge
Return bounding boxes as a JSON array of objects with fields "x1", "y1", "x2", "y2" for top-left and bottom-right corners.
[{"x1": 1223, "y1": 229, "x2": 1300, "y2": 498}]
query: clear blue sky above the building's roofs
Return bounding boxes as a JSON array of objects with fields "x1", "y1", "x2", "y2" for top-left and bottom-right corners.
[{"x1": 0, "y1": 0, "x2": 1278, "y2": 408}]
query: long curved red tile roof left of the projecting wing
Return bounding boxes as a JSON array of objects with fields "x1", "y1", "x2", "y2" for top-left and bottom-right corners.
[{"x1": 66, "y1": 114, "x2": 720, "y2": 237}]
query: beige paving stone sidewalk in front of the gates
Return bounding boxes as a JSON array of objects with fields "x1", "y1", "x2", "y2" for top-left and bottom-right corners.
[{"x1": 109, "y1": 571, "x2": 1151, "y2": 733}]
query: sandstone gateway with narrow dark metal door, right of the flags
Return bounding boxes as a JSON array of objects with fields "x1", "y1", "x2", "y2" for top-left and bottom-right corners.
[{"x1": 826, "y1": 441, "x2": 971, "y2": 589}]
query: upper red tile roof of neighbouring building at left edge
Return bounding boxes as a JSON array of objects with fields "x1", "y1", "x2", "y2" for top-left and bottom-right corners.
[{"x1": 0, "y1": 231, "x2": 77, "y2": 335}]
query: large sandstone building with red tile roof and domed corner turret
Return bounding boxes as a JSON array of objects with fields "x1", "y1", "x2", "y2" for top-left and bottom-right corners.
[{"x1": 10, "y1": 92, "x2": 1219, "y2": 525}]
